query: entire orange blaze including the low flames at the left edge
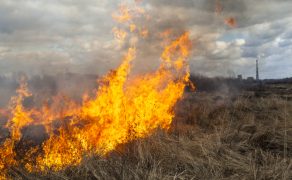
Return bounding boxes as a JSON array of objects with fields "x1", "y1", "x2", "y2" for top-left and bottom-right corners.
[{"x1": 0, "y1": 0, "x2": 191, "y2": 177}]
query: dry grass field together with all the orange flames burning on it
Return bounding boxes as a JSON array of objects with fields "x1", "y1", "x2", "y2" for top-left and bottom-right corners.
[{"x1": 0, "y1": 2, "x2": 292, "y2": 179}]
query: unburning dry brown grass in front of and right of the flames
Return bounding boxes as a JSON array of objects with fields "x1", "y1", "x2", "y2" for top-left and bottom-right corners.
[{"x1": 5, "y1": 83, "x2": 292, "y2": 179}]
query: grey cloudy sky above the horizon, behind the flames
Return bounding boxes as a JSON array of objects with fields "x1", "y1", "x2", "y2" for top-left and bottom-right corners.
[{"x1": 0, "y1": 0, "x2": 292, "y2": 78}]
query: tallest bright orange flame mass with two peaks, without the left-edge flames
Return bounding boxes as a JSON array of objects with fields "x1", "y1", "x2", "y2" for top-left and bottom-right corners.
[{"x1": 37, "y1": 33, "x2": 190, "y2": 170}]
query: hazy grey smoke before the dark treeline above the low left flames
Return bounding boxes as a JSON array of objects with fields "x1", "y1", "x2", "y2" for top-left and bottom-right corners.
[{"x1": 0, "y1": 73, "x2": 98, "y2": 110}]
